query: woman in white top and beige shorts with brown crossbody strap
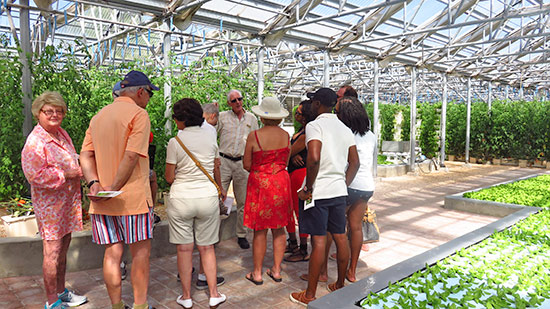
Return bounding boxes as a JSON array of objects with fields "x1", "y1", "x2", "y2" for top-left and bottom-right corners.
[{"x1": 165, "y1": 98, "x2": 226, "y2": 308}]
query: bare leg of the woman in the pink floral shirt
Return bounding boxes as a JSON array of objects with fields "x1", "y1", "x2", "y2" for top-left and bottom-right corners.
[{"x1": 42, "y1": 234, "x2": 66, "y2": 304}]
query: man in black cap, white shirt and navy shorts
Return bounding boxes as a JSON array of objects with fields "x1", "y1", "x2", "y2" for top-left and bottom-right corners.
[{"x1": 290, "y1": 88, "x2": 359, "y2": 306}]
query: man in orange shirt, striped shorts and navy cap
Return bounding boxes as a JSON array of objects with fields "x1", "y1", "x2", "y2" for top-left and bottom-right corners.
[{"x1": 80, "y1": 71, "x2": 159, "y2": 309}]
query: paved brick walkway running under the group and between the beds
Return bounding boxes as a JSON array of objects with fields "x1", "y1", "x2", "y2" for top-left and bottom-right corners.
[{"x1": 0, "y1": 162, "x2": 546, "y2": 309}]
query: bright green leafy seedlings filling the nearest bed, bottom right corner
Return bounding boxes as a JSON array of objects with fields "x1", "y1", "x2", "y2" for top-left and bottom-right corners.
[{"x1": 360, "y1": 210, "x2": 550, "y2": 308}]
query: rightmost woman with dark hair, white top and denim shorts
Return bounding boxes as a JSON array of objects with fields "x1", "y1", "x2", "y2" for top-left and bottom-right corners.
[{"x1": 334, "y1": 97, "x2": 376, "y2": 282}]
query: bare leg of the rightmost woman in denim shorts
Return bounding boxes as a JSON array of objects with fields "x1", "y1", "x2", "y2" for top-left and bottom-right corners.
[{"x1": 346, "y1": 199, "x2": 367, "y2": 282}]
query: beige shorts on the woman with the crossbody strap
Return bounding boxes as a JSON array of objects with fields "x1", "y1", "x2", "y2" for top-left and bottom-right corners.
[{"x1": 166, "y1": 196, "x2": 220, "y2": 246}]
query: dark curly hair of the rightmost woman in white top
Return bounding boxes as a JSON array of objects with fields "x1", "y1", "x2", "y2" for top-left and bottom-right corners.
[{"x1": 338, "y1": 97, "x2": 370, "y2": 136}]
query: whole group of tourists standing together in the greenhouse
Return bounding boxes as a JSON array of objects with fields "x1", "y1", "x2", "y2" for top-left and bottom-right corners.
[{"x1": 21, "y1": 71, "x2": 375, "y2": 309}]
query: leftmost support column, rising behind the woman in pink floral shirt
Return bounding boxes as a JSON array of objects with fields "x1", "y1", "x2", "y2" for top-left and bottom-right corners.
[{"x1": 19, "y1": 0, "x2": 32, "y2": 137}]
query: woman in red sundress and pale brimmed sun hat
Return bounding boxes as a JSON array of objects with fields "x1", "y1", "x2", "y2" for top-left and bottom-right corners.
[{"x1": 243, "y1": 97, "x2": 292, "y2": 285}]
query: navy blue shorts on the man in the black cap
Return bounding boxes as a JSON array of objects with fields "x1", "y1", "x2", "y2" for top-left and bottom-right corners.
[{"x1": 298, "y1": 196, "x2": 346, "y2": 236}]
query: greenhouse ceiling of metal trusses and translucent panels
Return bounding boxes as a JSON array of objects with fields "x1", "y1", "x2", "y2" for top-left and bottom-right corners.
[{"x1": 0, "y1": 0, "x2": 550, "y2": 102}]
